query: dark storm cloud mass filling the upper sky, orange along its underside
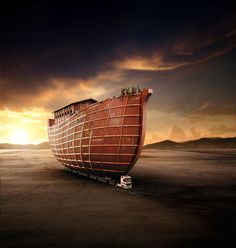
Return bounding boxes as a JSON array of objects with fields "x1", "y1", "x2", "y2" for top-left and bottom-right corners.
[{"x1": 1, "y1": 1, "x2": 236, "y2": 107}]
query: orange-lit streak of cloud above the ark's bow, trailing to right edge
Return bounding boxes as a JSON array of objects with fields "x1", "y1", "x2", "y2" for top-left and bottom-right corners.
[{"x1": 113, "y1": 23, "x2": 236, "y2": 71}]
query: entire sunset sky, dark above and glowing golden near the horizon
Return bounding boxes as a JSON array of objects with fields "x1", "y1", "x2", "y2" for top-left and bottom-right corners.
[{"x1": 0, "y1": 1, "x2": 236, "y2": 143}]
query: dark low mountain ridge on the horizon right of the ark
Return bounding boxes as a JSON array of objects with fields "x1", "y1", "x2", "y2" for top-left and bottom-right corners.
[{"x1": 144, "y1": 137, "x2": 236, "y2": 149}]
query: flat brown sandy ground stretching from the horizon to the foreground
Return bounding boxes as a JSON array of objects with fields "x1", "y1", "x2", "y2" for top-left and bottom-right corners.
[{"x1": 0, "y1": 150, "x2": 236, "y2": 248}]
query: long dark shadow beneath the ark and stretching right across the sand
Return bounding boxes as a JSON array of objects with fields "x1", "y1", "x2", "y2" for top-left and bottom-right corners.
[{"x1": 54, "y1": 165, "x2": 236, "y2": 211}]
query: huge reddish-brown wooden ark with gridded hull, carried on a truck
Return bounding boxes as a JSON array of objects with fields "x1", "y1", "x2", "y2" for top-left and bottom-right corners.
[{"x1": 48, "y1": 88, "x2": 152, "y2": 178}]
